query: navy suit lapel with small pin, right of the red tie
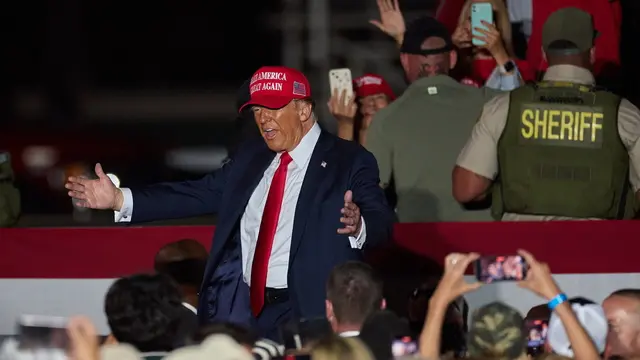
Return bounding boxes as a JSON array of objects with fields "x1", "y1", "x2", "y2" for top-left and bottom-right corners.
[{"x1": 289, "y1": 131, "x2": 339, "y2": 259}]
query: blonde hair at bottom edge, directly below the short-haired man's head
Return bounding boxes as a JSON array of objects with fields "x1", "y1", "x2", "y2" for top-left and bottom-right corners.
[{"x1": 311, "y1": 335, "x2": 374, "y2": 360}]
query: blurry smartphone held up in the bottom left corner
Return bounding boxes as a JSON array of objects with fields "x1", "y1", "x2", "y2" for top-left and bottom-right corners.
[{"x1": 17, "y1": 315, "x2": 69, "y2": 349}]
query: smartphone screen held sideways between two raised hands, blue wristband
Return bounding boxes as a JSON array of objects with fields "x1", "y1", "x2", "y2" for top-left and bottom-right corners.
[{"x1": 475, "y1": 255, "x2": 528, "y2": 284}]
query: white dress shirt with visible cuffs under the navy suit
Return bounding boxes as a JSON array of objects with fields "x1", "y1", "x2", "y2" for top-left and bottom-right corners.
[{"x1": 115, "y1": 123, "x2": 367, "y2": 288}]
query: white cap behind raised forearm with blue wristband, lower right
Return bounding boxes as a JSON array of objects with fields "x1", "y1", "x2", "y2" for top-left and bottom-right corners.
[{"x1": 547, "y1": 303, "x2": 609, "y2": 357}]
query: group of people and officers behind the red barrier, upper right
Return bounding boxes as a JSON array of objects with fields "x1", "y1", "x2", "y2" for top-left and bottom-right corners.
[{"x1": 329, "y1": 0, "x2": 640, "y2": 222}]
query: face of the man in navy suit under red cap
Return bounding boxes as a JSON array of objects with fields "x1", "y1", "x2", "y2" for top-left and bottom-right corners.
[{"x1": 253, "y1": 100, "x2": 314, "y2": 152}]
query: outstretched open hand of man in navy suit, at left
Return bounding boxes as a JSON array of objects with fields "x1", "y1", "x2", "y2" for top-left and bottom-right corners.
[{"x1": 65, "y1": 164, "x2": 123, "y2": 211}]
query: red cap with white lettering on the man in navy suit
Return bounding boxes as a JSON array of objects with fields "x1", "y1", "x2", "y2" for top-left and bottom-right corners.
[{"x1": 238, "y1": 66, "x2": 311, "y2": 111}]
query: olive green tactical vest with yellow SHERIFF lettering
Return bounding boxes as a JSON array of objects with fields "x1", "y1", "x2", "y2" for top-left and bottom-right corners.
[{"x1": 492, "y1": 82, "x2": 635, "y2": 219}]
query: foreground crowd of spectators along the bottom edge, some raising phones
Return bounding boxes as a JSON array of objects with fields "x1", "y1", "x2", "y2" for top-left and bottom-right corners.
[{"x1": 0, "y1": 239, "x2": 640, "y2": 360}]
